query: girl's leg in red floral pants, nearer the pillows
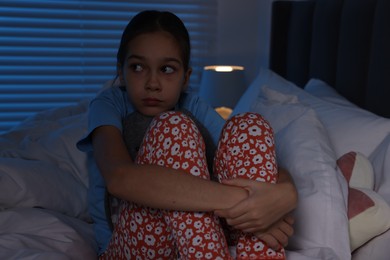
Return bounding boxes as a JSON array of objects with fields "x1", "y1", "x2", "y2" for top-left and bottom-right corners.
[{"x1": 214, "y1": 113, "x2": 285, "y2": 259}]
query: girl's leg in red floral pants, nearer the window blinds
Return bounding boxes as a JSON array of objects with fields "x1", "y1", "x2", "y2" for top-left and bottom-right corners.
[{"x1": 102, "y1": 112, "x2": 230, "y2": 259}]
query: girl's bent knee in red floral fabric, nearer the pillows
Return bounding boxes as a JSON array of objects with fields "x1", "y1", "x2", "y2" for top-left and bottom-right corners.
[{"x1": 214, "y1": 112, "x2": 277, "y2": 182}]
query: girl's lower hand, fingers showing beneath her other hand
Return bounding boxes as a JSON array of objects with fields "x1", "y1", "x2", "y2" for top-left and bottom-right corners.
[{"x1": 254, "y1": 214, "x2": 294, "y2": 251}]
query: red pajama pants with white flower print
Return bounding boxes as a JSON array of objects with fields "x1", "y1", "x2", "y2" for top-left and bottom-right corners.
[{"x1": 101, "y1": 111, "x2": 285, "y2": 259}]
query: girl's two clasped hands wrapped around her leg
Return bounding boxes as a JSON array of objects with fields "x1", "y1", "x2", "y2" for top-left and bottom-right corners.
[{"x1": 214, "y1": 169, "x2": 298, "y2": 250}]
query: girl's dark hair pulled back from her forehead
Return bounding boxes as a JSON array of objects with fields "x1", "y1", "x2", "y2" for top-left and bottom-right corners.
[{"x1": 117, "y1": 10, "x2": 191, "y2": 71}]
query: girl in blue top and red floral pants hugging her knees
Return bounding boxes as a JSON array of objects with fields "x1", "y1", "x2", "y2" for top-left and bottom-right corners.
[{"x1": 78, "y1": 11, "x2": 297, "y2": 259}]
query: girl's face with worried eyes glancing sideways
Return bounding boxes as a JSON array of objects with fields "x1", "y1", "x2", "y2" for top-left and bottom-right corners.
[{"x1": 118, "y1": 31, "x2": 191, "y2": 116}]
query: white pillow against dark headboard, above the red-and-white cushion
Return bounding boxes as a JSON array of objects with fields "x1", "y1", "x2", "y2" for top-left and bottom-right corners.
[{"x1": 304, "y1": 79, "x2": 390, "y2": 157}]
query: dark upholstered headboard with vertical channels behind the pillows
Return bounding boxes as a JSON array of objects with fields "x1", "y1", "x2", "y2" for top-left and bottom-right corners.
[{"x1": 269, "y1": 0, "x2": 390, "y2": 117}]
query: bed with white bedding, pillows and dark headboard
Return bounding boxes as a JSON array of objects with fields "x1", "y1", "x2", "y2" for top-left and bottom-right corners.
[{"x1": 0, "y1": 0, "x2": 390, "y2": 260}]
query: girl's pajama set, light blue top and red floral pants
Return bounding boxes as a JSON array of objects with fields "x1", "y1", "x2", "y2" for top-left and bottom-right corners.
[{"x1": 78, "y1": 87, "x2": 284, "y2": 259}]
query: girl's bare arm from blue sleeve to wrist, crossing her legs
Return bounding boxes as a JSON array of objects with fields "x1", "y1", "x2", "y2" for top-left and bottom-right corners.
[{"x1": 92, "y1": 126, "x2": 248, "y2": 211}]
